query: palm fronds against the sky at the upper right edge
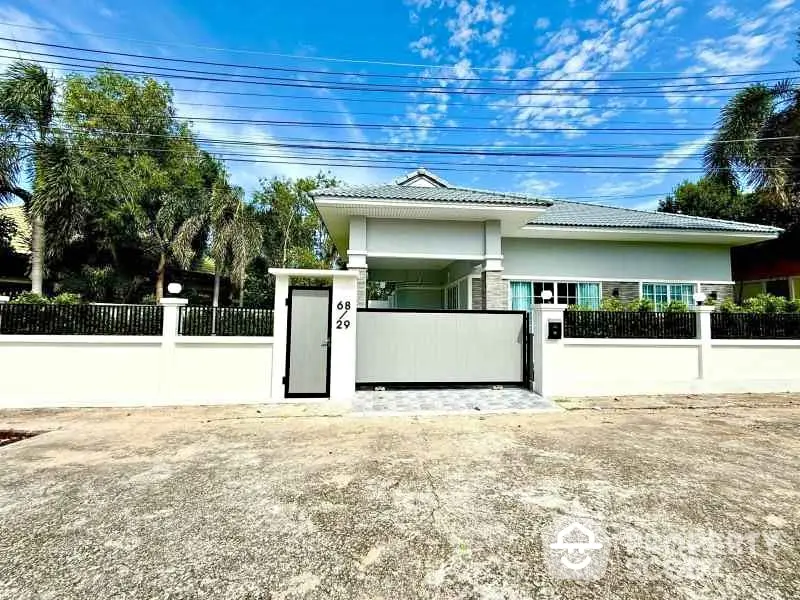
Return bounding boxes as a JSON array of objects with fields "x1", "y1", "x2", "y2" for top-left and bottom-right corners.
[{"x1": 705, "y1": 37, "x2": 800, "y2": 206}]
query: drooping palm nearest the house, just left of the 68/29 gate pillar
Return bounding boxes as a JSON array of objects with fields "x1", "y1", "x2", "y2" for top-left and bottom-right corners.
[{"x1": 181, "y1": 178, "x2": 262, "y2": 307}]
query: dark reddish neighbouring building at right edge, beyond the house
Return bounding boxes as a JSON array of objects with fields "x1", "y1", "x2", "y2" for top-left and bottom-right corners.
[{"x1": 731, "y1": 231, "x2": 800, "y2": 301}]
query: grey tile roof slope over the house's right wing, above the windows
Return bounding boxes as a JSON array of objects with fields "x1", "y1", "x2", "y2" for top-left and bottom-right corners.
[{"x1": 530, "y1": 200, "x2": 781, "y2": 233}]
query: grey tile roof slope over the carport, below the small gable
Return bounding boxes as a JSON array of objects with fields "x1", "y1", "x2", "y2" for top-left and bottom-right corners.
[{"x1": 311, "y1": 185, "x2": 550, "y2": 206}]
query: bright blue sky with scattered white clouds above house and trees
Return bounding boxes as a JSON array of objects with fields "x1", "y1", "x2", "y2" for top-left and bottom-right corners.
[{"x1": 0, "y1": 0, "x2": 800, "y2": 208}]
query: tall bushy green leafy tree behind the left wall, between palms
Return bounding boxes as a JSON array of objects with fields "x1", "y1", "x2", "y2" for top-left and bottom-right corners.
[{"x1": 64, "y1": 70, "x2": 211, "y2": 301}]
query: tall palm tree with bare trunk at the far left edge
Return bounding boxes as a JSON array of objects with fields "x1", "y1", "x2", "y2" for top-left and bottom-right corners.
[{"x1": 0, "y1": 61, "x2": 85, "y2": 294}]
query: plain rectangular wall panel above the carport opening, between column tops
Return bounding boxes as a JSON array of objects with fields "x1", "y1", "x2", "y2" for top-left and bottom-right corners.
[{"x1": 367, "y1": 219, "x2": 484, "y2": 260}]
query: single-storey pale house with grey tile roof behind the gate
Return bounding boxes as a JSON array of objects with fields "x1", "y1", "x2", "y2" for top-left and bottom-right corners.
[{"x1": 312, "y1": 169, "x2": 781, "y2": 310}]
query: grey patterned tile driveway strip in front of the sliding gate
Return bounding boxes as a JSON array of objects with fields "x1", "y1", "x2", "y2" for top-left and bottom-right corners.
[{"x1": 353, "y1": 387, "x2": 560, "y2": 415}]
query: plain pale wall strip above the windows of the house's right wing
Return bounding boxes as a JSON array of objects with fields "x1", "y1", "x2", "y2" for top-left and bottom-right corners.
[{"x1": 502, "y1": 238, "x2": 731, "y2": 283}]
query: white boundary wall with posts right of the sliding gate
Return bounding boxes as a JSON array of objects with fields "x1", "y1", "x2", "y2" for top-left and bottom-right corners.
[{"x1": 533, "y1": 305, "x2": 800, "y2": 397}]
